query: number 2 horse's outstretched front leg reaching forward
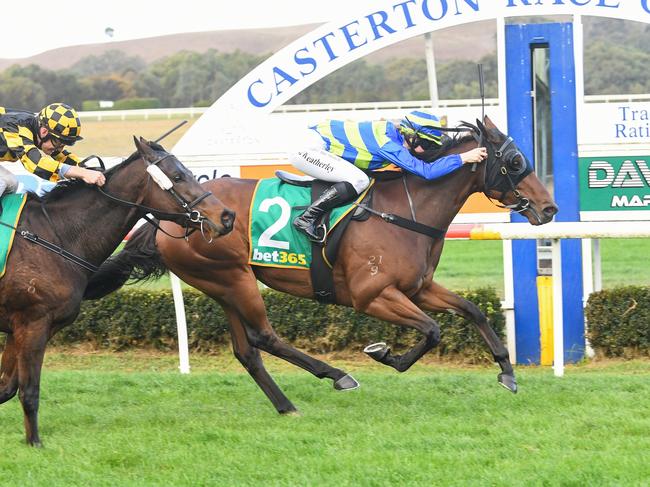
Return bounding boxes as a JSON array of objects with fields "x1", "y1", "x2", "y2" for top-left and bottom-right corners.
[{"x1": 413, "y1": 281, "x2": 517, "y2": 393}]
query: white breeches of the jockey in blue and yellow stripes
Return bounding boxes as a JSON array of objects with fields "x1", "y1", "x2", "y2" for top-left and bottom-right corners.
[{"x1": 289, "y1": 129, "x2": 370, "y2": 193}]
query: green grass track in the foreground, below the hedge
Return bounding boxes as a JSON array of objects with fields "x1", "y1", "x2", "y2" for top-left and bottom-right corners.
[{"x1": 0, "y1": 353, "x2": 650, "y2": 487}]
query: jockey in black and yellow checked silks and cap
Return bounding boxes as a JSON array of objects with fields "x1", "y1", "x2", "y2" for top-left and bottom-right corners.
[{"x1": 0, "y1": 103, "x2": 106, "y2": 196}]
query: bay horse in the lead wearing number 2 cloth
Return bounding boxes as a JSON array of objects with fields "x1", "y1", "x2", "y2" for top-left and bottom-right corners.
[{"x1": 86, "y1": 117, "x2": 558, "y2": 413}]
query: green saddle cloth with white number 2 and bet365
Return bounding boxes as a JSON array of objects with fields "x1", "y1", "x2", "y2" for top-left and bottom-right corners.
[{"x1": 248, "y1": 178, "x2": 354, "y2": 269}]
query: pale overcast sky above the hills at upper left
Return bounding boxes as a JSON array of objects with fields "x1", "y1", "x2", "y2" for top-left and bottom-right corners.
[{"x1": 0, "y1": 0, "x2": 372, "y2": 58}]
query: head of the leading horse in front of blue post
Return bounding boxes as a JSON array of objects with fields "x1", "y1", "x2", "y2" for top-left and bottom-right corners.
[{"x1": 476, "y1": 116, "x2": 558, "y2": 225}]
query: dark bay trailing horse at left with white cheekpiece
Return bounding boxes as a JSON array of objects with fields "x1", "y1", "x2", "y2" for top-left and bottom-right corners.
[{"x1": 0, "y1": 139, "x2": 234, "y2": 446}]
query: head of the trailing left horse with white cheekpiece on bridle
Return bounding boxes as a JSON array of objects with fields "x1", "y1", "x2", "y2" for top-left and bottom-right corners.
[{"x1": 133, "y1": 137, "x2": 235, "y2": 239}]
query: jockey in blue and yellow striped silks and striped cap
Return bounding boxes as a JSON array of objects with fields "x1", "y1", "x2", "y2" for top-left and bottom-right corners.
[{"x1": 289, "y1": 110, "x2": 487, "y2": 242}]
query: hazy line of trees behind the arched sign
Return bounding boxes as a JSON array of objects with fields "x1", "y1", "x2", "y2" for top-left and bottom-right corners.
[{"x1": 0, "y1": 19, "x2": 650, "y2": 111}]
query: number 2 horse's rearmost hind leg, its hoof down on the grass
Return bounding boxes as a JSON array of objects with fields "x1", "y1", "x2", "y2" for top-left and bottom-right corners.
[{"x1": 223, "y1": 306, "x2": 296, "y2": 414}]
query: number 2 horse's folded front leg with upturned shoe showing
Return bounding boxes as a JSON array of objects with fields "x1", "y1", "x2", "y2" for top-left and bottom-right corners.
[{"x1": 359, "y1": 286, "x2": 440, "y2": 372}]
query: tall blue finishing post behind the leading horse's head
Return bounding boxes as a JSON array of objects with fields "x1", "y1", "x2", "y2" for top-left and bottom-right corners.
[{"x1": 506, "y1": 23, "x2": 585, "y2": 364}]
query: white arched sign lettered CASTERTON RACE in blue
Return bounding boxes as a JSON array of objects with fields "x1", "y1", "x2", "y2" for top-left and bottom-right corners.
[{"x1": 174, "y1": 0, "x2": 650, "y2": 156}]
